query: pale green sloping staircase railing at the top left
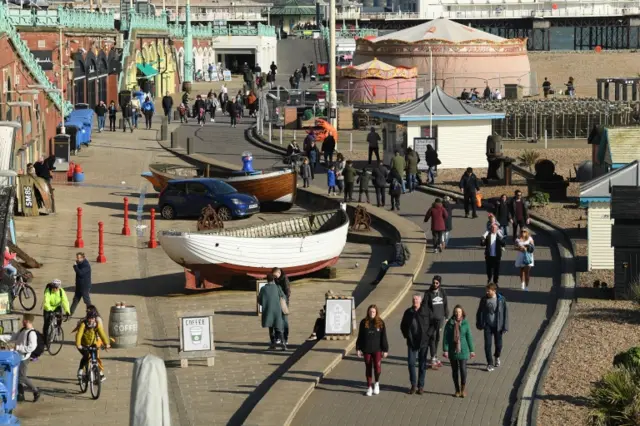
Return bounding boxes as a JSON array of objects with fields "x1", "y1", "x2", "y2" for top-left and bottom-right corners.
[{"x1": 0, "y1": 5, "x2": 73, "y2": 117}]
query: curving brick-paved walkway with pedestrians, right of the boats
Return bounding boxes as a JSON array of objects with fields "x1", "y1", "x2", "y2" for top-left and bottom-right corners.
[{"x1": 180, "y1": 117, "x2": 560, "y2": 426}]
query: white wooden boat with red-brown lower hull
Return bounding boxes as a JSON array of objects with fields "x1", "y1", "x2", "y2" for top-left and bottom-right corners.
[{"x1": 158, "y1": 205, "x2": 349, "y2": 290}]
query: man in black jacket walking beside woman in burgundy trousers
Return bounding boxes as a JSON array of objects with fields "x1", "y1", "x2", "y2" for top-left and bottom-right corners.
[{"x1": 400, "y1": 294, "x2": 431, "y2": 395}]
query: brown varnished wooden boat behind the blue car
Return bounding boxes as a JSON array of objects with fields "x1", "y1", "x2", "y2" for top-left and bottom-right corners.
[{"x1": 142, "y1": 164, "x2": 297, "y2": 205}]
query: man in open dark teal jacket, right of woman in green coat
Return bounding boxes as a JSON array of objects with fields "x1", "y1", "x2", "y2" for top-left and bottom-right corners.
[{"x1": 476, "y1": 283, "x2": 509, "y2": 371}]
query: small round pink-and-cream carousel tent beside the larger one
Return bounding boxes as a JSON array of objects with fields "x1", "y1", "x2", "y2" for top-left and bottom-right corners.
[{"x1": 338, "y1": 58, "x2": 418, "y2": 105}]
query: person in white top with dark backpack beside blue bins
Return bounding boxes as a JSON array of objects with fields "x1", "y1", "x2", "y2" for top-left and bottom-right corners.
[{"x1": 0, "y1": 314, "x2": 44, "y2": 402}]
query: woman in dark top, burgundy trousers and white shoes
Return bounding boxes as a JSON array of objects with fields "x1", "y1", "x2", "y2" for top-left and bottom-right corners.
[{"x1": 356, "y1": 305, "x2": 389, "y2": 396}]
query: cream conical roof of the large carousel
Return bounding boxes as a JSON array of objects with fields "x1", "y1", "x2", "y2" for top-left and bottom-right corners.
[{"x1": 374, "y1": 18, "x2": 507, "y2": 43}]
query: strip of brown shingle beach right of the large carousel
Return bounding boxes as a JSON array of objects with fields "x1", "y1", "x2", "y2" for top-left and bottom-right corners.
[{"x1": 529, "y1": 51, "x2": 640, "y2": 97}]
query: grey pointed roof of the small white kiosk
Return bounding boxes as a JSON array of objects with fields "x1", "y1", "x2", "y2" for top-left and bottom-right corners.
[{"x1": 370, "y1": 86, "x2": 504, "y2": 122}]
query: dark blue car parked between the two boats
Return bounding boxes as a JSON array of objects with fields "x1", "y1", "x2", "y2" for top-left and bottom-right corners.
[{"x1": 158, "y1": 178, "x2": 260, "y2": 220}]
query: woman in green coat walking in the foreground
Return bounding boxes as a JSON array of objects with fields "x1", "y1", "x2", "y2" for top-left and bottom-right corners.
[{"x1": 442, "y1": 305, "x2": 476, "y2": 398}]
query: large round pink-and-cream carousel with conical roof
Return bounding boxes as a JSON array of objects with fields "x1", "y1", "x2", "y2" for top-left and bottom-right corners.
[{"x1": 354, "y1": 18, "x2": 535, "y2": 95}]
